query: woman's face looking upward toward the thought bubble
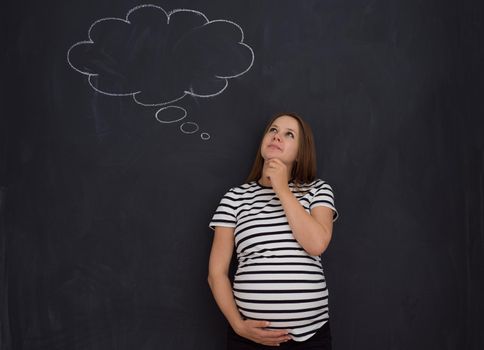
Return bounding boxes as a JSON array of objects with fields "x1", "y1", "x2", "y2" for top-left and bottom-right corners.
[{"x1": 261, "y1": 115, "x2": 300, "y2": 167}]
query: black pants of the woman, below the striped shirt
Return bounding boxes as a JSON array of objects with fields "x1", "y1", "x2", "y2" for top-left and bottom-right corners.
[{"x1": 227, "y1": 321, "x2": 331, "y2": 350}]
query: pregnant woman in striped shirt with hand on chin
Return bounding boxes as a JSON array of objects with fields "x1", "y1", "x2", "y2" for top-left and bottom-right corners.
[{"x1": 208, "y1": 114, "x2": 338, "y2": 350}]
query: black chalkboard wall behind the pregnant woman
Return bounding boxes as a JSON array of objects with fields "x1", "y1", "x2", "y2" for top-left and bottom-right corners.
[{"x1": 0, "y1": 0, "x2": 484, "y2": 350}]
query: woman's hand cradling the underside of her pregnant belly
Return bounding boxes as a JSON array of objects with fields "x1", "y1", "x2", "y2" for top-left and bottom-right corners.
[{"x1": 234, "y1": 320, "x2": 291, "y2": 346}]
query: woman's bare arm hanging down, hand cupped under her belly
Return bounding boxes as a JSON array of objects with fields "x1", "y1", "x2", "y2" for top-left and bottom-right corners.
[{"x1": 208, "y1": 226, "x2": 290, "y2": 346}]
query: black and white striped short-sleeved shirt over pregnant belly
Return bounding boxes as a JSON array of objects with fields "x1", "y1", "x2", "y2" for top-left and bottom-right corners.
[{"x1": 209, "y1": 179, "x2": 338, "y2": 341}]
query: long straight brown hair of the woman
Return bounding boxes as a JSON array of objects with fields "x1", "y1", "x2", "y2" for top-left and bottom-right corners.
[{"x1": 246, "y1": 113, "x2": 316, "y2": 185}]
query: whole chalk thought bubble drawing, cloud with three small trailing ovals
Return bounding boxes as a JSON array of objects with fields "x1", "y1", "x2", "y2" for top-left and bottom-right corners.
[{"x1": 67, "y1": 5, "x2": 254, "y2": 139}]
